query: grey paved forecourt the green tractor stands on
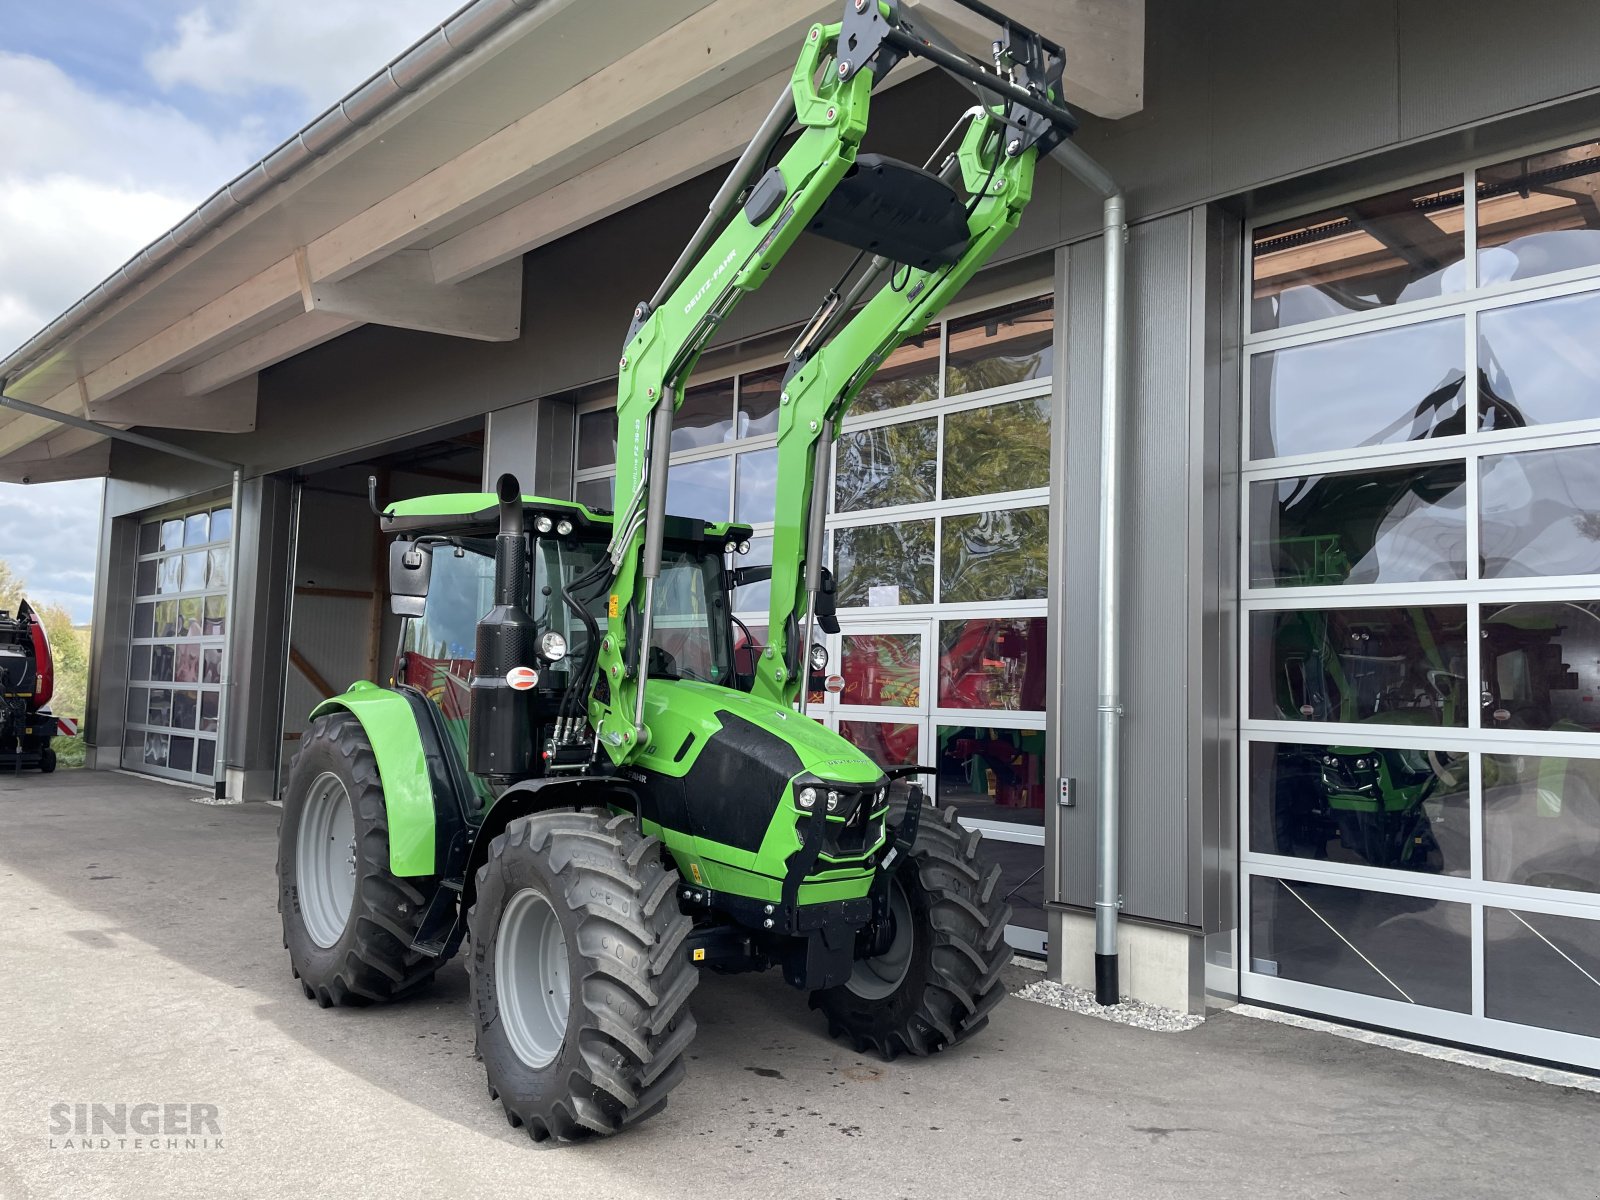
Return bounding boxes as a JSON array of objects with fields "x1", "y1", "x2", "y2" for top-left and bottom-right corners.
[{"x1": 0, "y1": 771, "x2": 1600, "y2": 1200}]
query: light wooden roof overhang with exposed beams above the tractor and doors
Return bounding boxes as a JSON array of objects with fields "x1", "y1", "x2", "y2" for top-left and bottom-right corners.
[{"x1": 0, "y1": 0, "x2": 1144, "y2": 482}]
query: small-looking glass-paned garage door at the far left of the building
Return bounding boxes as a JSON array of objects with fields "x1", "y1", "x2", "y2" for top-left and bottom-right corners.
[{"x1": 122, "y1": 504, "x2": 234, "y2": 784}]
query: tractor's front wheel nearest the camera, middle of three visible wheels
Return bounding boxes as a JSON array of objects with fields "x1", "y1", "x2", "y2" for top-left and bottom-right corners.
[{"x1": 467, "y1": 811, "x2": 699, "y2": 1142}]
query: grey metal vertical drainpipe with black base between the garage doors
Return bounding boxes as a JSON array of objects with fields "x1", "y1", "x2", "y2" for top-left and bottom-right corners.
[{"x1": 1054, "y1": 141, "x2": 1128, "y2": 1005}]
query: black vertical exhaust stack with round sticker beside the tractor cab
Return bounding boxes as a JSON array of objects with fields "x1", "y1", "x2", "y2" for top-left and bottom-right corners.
[{"x1": 467, "y1": 474, "x2": 539, "y2": 781}]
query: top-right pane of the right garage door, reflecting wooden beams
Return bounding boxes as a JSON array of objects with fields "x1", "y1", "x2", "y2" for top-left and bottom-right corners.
[{"x1": 1478, "y1": 142, "x2": 1600, "y2": 285}]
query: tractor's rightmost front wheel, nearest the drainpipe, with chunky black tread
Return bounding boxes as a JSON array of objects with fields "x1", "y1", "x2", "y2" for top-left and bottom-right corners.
[{"x1": 811, "y1": 802, "x2": 1011, "y2": 1061}]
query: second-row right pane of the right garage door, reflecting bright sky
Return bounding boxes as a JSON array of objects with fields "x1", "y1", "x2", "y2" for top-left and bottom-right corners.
[{"x1": 1478, "y1": 291, "x2": 1600, "y2": 429}]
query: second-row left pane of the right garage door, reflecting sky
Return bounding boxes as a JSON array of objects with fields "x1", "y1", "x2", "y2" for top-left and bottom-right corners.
[{"x1": 1250, "y1": 317, "x2": 1467, "y2": 458}]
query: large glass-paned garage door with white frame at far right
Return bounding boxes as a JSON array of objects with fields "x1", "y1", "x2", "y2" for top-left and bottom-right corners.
[{"x1": 1240, "y1": 142, "x2": 1600, "y2": 1067}]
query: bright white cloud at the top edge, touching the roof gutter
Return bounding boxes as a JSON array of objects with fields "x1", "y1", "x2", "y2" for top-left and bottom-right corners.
[{"x1": 146, "y1": 0, "x2": 461, "y2": 109}]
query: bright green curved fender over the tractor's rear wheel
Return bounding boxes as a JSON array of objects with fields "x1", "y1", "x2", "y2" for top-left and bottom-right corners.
[{"x1": 310, "y1": 680, "x2": 435, "y2": 877}]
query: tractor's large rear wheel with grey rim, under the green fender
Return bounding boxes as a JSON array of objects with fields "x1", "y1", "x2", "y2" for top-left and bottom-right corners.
[{"x1": 278, "y1": 712, "x2": 445, "y2": 1008}]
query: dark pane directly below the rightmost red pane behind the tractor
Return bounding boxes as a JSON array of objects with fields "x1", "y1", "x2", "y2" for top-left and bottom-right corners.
[{"x1": 936, "y1": 725, "x2": 1045, "y2": 826}]
